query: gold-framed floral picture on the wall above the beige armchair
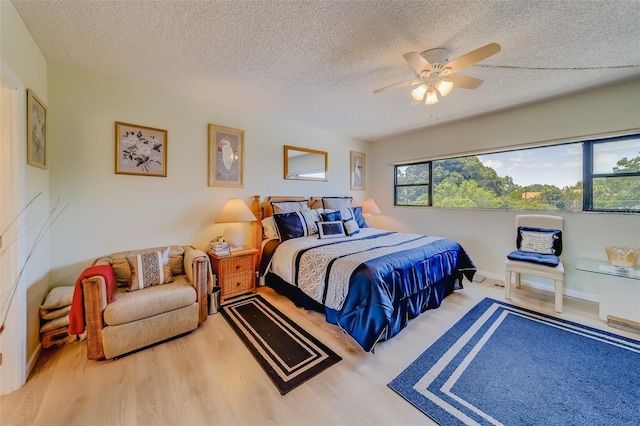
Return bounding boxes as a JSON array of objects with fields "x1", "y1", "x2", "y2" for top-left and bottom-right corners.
[{"x1": 116, "y1": 121, "x2": 167, "y2": 177}]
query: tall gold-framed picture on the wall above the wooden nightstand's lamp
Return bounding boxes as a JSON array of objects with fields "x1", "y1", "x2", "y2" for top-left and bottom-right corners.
[{"x1": 209, "y1": 124, "x2": 244, "y2": 188}]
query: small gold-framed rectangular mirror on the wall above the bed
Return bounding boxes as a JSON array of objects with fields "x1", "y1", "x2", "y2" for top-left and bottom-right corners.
[{"x1": 284, "y1": 145, "x2": 329, "y2": 182}]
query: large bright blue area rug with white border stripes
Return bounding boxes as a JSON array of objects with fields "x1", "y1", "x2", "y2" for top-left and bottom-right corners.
[{"x1": 389, "y1": 298, "x2": 640, "y2": 425}]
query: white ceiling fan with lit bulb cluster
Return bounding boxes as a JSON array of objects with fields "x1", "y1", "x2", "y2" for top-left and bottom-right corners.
[{"x1": 373, "y1": 43, "x2": 500, "y2": 105}]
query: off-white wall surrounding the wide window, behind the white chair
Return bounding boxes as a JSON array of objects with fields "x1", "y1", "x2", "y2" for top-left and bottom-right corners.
[{"x1": 368, "y1": 80, "x2": 640, "y2": 300}]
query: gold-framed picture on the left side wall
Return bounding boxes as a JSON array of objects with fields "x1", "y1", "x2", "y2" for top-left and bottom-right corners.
[{"x1": 27, "y1": 89, "x2": 47, "y2": 169}]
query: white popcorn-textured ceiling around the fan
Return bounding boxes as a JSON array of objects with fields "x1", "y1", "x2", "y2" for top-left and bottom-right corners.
[{"x1": 13, "y1": 0, "x2": 640, "y2": 140}]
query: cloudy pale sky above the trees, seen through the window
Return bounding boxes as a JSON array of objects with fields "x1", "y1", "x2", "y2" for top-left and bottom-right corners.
[{"x1": 478, "y1": 139, "x2": 640, "y2": 188}]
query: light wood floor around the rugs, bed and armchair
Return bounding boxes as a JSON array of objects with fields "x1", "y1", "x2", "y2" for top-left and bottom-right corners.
[{"x1": 0, "y1": 279, "x2": 638, "y2": 426}]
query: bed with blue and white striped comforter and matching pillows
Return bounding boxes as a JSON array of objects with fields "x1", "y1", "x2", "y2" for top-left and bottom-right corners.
[{"x1": 254, "y1": 197, "x2": 475, "y2": 352}]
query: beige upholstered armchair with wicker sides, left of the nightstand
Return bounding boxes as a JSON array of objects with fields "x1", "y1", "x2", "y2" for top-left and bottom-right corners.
[{"x1": 82, "y1": 246, "x2": 213, "y2": 360}]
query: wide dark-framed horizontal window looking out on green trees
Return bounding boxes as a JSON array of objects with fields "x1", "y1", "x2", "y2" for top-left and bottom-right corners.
[{"x1": 394, "y1": 135, "x2": 640, "y2": 212}]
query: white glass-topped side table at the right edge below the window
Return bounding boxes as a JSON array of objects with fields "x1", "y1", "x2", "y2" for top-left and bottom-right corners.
[{"x1": 576, "y1": 259, "x2": 640, "y2": 332}]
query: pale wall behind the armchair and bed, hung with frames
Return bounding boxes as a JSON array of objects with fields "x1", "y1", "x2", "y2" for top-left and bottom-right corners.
[{"x1": 49, "y1": 65, "x2": 368, "y2": 286}]
